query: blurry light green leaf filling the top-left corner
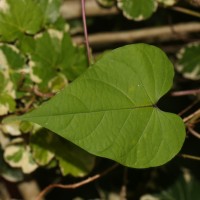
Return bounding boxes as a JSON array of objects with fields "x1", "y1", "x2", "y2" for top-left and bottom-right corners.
[{"x1": 0, "y1": 0, "x2": 45, "y2": 41}]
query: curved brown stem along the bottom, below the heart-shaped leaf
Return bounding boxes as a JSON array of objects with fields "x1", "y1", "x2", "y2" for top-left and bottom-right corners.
[{"x1": 36, "y1": 164, "x2": 119, "y2": 200}]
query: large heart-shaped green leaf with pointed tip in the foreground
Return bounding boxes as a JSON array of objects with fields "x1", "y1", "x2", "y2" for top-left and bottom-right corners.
[{"x1": 20, "y1": 44, "x2": 185, "y2": 168}]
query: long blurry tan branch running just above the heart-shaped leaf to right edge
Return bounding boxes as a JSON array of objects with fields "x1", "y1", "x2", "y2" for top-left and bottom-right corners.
[{"x1": 73, "y1": 22, "x2": 200, "y2": 46}]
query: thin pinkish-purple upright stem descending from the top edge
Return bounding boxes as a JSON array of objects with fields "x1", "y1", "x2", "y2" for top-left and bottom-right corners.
[{"x1": 81, "y1": 0, "x2": 93, "y2": 65}]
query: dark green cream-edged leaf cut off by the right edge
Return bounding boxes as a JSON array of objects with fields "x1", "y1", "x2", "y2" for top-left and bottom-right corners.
[{"x1": 176, "y1": 43, "x2": 200, "y2": 80}]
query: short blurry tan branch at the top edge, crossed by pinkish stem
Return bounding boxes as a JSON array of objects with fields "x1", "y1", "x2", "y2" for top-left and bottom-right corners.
[{"x1": 60, "y1": 0, "x2": 119, "y2": 19}]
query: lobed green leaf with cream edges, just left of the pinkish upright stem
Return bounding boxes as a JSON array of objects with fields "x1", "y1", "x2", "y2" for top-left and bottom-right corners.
[{"x1": 29, "y1": 29, "x2": 87, "y2": 91}]
